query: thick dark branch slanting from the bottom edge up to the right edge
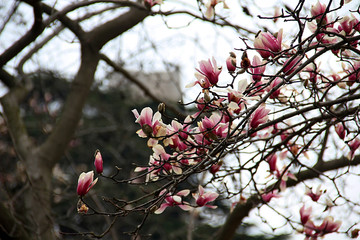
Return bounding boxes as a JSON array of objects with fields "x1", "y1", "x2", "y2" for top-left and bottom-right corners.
[{"x1": 216, "y1": 155, "x2": 360, "y2": 240}]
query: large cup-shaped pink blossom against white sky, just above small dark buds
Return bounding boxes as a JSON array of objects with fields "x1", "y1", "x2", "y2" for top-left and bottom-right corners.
[{"x1": 254, "y1": 29, "x2": 283, "y2": 58}]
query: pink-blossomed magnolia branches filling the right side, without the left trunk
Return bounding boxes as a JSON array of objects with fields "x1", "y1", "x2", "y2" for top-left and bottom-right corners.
[{"x1": 78, "y1": 1, "x2": 360, "y2": 240}]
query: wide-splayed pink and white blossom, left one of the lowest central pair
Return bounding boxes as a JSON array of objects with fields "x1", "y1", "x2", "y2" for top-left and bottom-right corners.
[{"x1": 154, "y1": 189, "x2": 191, "y2": 214}]
